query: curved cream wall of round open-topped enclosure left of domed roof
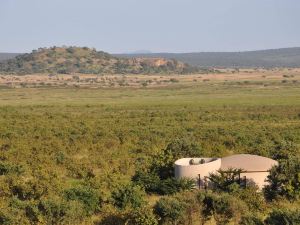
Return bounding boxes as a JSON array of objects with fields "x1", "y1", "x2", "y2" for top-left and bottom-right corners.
[{"x1": 175, "y1": 158, "x2": 221, "y2": 179}]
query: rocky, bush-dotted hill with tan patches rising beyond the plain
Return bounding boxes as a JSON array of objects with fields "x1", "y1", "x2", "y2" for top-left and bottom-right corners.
[{"x1": 0, "y1": 47, "x2": 196, "y2": 74}]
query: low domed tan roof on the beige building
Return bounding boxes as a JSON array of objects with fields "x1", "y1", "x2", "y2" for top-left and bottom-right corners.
[{"x1": 221, "y1": 154, "x2": 278, "y2": 171}]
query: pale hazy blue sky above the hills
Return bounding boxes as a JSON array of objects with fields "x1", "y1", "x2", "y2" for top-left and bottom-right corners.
[{"x1": 0, "y1": 0, "x2": 300, "y2": 53}]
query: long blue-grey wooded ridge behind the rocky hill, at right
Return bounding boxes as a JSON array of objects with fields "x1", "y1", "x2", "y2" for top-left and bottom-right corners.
[{"x1": 116, "y1": 47, "x2": 300, "y2": 68}]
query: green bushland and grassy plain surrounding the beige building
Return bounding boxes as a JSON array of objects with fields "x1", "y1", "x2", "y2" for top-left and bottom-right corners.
[{"x1": 0, "y1": 82, "x2": 300, "y2": 225}]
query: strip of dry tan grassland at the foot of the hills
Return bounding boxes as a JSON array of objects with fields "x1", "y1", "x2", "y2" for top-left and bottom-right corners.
[{"x1": 0, "y1": 68, "x2": 300, "y2": 88}]
